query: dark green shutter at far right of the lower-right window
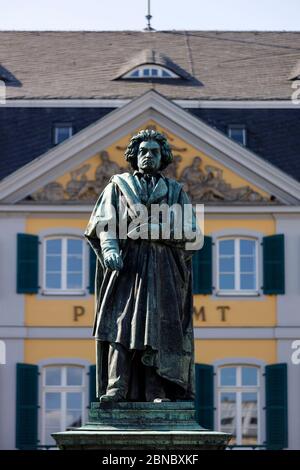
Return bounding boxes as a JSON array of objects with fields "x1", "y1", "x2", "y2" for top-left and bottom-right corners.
[{"x1": 265, "y1": 364, "x2": 288, "y2": 449}]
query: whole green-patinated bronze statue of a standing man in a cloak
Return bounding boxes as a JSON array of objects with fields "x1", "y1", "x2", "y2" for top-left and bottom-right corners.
[{"x1": 85, "y1": 130, "x2": 199, "y2": 402}]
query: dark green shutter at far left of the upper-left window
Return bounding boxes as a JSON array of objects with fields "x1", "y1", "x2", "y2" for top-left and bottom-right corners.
[{"x1": 17, "y1": 233, "x2": 39, "y2": 294}]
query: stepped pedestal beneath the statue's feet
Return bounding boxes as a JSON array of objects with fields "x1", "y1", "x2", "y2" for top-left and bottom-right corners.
[{"x1": 52, "y1": 402, "x2": 230, "y2": 452}]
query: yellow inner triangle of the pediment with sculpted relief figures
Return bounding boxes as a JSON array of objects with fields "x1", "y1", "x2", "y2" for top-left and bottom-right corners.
[{"x1": 26, "y1": 120, "x2": 276, "y2": 204}]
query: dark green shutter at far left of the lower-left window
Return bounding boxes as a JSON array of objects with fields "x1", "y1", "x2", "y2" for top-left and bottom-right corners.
[{"x1": 16, "y1": 364, "x2": 38, "y2": 449}]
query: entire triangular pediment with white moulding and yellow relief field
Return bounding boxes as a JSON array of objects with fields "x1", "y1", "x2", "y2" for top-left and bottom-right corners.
[{"x1": 0, "y1": 92, "x2": 300, "y2": 204}]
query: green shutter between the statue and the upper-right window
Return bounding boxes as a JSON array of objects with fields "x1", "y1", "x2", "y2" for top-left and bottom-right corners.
[{"x1": 193, "y1": 236, "x2": 212, "y2": 294}]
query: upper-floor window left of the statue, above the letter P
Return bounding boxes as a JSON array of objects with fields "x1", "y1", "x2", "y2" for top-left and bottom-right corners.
[{"x1": 43, "y1": 236, "x2": 86, "y2": 294}]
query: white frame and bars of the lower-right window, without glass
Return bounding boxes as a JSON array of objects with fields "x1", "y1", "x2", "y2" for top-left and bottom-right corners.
[{"x1": 217, "y1": 364, "x2": 262, "y2": 447}]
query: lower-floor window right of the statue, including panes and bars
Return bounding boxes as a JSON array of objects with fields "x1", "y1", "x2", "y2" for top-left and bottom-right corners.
[{"x1": 217, "y1": 365, "x2": 261, "y2": 445}]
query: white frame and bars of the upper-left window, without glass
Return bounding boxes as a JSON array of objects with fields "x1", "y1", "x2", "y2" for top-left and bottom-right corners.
[{"x1": 42, "y1": 235, "x2": 87, "y2": 295}]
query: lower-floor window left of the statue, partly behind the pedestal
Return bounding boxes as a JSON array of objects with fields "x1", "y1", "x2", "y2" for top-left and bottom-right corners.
[{"x1": 42, "y1": 365, "x2": 86, "y2": 445}]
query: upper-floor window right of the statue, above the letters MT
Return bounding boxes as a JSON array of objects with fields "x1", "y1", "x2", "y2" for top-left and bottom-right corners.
[{"x1": 217, "y1": 237, "x2": 258, "y2": 294}]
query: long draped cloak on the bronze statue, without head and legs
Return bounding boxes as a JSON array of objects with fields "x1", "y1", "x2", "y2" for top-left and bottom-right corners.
[{"x1": 85, "y1": 173, "x2": 197, "y2": 398}]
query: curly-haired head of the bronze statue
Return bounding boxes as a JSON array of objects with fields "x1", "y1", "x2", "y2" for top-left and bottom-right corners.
[{"x1": 125, "y1": 129, "x2": 173, "y2": 173}]
